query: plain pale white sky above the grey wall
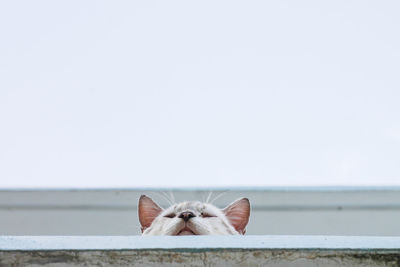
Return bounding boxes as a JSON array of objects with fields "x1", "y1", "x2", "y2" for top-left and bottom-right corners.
[{"x1": 0, "y1": 0, "x2": 400, "y2": 187}]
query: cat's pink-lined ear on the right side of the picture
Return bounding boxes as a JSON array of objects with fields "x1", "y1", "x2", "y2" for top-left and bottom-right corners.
[{"x1": 222, "y1": 198, "x2": 250, "y2": 235}]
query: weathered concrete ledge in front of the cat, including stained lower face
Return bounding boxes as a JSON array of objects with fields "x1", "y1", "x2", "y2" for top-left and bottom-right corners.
[{"x1": 0, "y1": 236, "x2": 400, "y2": 266}]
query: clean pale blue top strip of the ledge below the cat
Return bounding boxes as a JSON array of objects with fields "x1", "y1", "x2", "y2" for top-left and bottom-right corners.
[{"x1": 0, "y1": 235, "x2": 400, "y2": 251}]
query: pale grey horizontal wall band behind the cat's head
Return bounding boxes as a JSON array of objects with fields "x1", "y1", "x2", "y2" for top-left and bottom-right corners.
[{"x1": 0, "y1": 188, "x2": 400, "y2": 236}]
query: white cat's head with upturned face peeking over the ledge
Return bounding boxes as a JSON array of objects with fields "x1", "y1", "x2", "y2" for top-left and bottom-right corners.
[{"x1": 138, "y1": 195, "x2": 250, "y2": 236}]
